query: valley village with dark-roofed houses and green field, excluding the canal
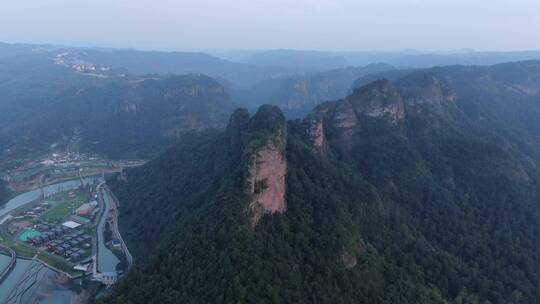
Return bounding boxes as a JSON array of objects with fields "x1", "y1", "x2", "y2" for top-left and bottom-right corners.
[{"x1": 0, "y1": 183, "x2": 122, "y2": 285}]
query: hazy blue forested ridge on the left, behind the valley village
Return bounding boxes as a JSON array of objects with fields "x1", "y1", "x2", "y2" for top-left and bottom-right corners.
[{"x1": 0, "y1": 49, "x2": 235, "y2": 165}]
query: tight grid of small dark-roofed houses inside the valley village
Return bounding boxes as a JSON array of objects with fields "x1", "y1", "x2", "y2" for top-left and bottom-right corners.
[{"x1": 27, "y1": 224, "x2": 92, "y2": 262}]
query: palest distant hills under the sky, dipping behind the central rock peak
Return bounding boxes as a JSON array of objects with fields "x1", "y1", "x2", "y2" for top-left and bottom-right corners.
[{"x1": 6, "y1": 44, "x2": 540, "y2": 117}]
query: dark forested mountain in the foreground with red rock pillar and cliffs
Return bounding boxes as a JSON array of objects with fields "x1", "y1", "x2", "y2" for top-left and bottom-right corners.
[{"x1": 104, "y1": 62, "x2": 540, "y2": 304}]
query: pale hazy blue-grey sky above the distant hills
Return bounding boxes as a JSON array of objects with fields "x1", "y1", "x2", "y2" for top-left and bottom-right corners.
[{"x1": 0, "y1": 0, "x2": 540, "y2": 50}]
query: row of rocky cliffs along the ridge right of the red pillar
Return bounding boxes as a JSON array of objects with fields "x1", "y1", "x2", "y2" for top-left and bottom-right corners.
[{"x1": 305, "y1": 76, "x2": 456, "y2": 151}]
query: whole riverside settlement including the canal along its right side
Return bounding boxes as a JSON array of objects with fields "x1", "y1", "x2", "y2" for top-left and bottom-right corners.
[{"x1": 0, "y1": 176, "x2": 132, "y2": 290}]
